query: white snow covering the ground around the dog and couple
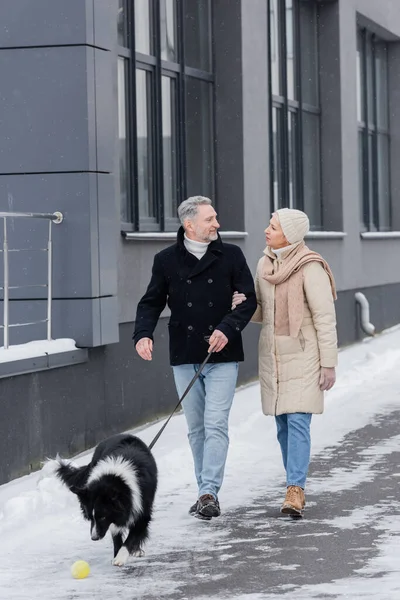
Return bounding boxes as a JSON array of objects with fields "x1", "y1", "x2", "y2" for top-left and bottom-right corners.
[{"x1": 0, "y1": 328, "x2": 400, "y2": 600}]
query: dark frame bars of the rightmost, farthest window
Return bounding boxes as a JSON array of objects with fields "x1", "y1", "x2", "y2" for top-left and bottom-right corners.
[{"x1": 357, "y1": 27, "x2": 392, "y2": 232}]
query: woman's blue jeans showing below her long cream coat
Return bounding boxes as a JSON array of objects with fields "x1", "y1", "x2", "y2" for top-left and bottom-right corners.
[{"x1": 275, "y1": 413, "x2": 312, "y2": 489}]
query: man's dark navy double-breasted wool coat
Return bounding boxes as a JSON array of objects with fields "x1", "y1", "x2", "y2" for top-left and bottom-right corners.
[{"x1": 133, "y1": 227, "x2": 257, "y2": 365}]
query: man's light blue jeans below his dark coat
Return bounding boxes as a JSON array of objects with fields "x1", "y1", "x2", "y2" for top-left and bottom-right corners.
[{"x1": 173, "y1": 362, "x2": 238, "y2": 498}]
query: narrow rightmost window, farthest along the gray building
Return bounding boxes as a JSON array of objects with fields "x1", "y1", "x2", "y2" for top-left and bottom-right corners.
[{"x1": 357, "y1": 29, "x2": 391, "y2": 231}]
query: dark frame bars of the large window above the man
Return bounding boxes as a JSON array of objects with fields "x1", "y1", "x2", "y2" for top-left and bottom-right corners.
[{"x1": 117, "y1": 0, "x2": 216, "y2": 232}]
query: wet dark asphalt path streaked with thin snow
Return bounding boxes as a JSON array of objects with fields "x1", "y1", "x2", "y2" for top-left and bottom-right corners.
[{"x1": 120, "y1": 410, "x2": 400, "y2": 600}]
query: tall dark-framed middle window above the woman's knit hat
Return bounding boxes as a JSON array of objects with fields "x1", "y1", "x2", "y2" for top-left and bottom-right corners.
[{"x1": 269, "y1": 0, "x2": 322, "y2": 229}]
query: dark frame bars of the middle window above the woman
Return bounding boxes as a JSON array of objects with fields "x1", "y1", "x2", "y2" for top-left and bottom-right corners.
[{"x1": 268, "y1": 0, "x2": 323, "y2": 230}]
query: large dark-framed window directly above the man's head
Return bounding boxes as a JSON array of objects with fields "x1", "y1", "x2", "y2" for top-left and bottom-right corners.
[{"x1": 118, "y1": 0, "x2": 214, "y2": 231}]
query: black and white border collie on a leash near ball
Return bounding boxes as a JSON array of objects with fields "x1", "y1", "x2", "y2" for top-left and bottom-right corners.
[{"x1": 55, "y1": 434, "x2": 157, "y2": 567}]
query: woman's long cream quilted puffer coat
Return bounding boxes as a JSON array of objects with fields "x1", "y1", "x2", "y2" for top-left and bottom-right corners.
[{"x1": 252, "y1": 251, "x2": 337, "y2": 415}]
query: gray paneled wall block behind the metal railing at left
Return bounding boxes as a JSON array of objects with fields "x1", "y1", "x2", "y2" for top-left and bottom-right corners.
[{"x1": 0, "y1": 0, "x2": 118, "y2": 346}]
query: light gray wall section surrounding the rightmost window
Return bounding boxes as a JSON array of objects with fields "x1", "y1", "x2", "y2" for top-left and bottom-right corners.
[{"x1": 329, "y1": 0, "x2": 400, "y2": 292}]
